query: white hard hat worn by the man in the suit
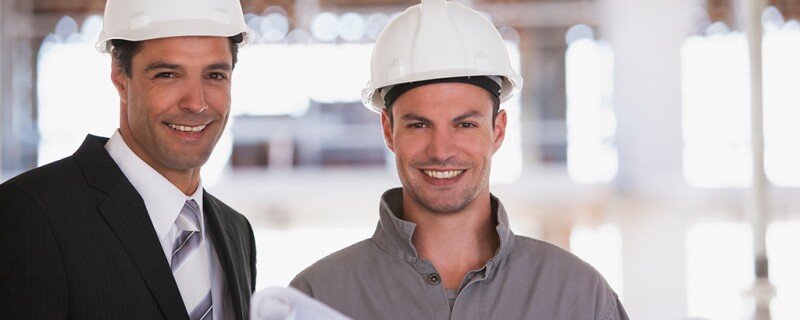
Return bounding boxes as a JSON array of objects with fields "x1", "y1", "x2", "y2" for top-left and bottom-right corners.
[{"x1": 95, "y1": 0, "x2": 253, "y2": 53}]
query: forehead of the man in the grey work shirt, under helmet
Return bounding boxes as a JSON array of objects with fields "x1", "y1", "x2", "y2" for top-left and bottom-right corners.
[{"x1": 392, "y1": 82, "x2": 493, "y2": 115}]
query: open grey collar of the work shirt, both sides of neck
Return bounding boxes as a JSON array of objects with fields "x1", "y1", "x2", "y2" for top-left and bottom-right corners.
[{"x1": 373, "y1": 188, "x2": 514, "y2": 264}]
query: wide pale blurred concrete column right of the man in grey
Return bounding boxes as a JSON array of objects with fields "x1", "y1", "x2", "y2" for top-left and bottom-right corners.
[{"x1": 598, "y1": 0, "x2": 700, "y2": 320}]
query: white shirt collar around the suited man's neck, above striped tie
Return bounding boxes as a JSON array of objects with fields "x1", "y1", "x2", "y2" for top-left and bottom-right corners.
[{"x1": 105, "y1": 130, "x2": 205, "y2": 240}]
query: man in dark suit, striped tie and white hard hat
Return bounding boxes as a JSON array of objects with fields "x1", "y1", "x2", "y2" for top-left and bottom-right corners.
[{"x1": 0, "y1": 0, "x2": 256, "y2": 319}]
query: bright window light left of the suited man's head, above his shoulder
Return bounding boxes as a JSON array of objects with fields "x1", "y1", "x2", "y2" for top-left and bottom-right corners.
[{"x1": 37, "y1": 38, "x2": 119, "y2": 165}]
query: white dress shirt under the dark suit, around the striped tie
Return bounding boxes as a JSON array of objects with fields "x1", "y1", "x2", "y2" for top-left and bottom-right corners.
[{"x1": 105, "y1": 130, "x2": 234, "y2": 319}]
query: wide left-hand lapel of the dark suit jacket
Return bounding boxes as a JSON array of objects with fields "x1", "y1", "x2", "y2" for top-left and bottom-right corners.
[{"x1": 75, "y1": 136, "x2": 188, "y2": 319}]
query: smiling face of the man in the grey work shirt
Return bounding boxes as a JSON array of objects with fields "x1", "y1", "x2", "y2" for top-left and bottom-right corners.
[{"x1": 381, "y1": 83, "x2": 506, "y2": 214}]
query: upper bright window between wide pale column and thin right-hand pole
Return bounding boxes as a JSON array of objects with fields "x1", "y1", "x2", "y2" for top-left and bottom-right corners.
[{"x1": 681, "y1": 33, "x2": 751, "y2": 188}]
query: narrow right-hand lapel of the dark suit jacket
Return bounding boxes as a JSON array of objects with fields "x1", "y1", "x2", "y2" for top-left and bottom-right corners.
[{"x1": 203, "y1": 192, "x2": 246, "y2": 319}]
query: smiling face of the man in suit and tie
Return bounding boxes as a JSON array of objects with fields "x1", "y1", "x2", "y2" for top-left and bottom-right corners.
[{"x1": 111, "y1": 37, "x2": 233, "y2": 192}]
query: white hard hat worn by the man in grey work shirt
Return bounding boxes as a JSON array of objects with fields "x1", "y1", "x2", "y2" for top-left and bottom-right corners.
[{"x1": 361, "y1": 0, "x2": 522, "y2": 112}]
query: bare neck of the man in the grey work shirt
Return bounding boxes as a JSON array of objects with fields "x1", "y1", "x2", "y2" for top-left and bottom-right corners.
[{"x1": 403, "y1": 194, "x2": 500, "y2": 289}]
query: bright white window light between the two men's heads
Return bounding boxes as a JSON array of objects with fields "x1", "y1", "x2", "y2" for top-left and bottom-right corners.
[{"x1": 231, "y1": 44, "x2": 372, "y2": 116}]
